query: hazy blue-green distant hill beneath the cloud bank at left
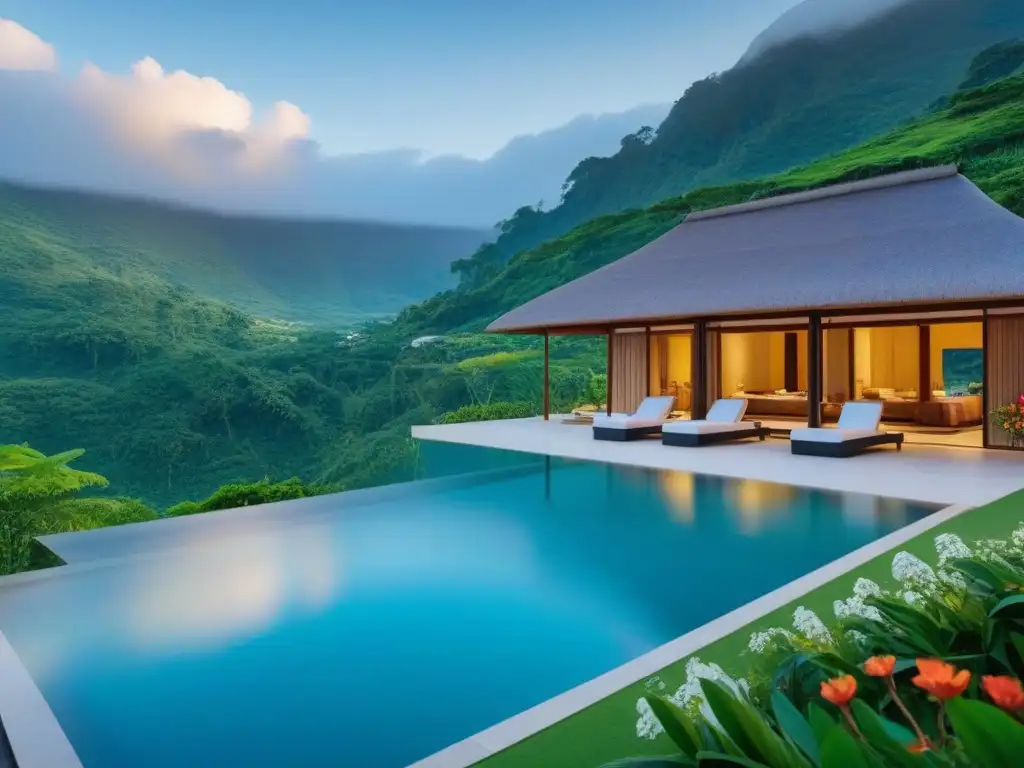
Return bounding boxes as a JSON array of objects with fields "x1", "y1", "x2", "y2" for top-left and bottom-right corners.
[{"x1": 0, "y1": 182, "x2": 488, "y2": 327}]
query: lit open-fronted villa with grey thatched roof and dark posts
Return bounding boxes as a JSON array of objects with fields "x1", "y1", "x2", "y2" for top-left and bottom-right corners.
[{"x1": 487, "y1": 165, "x2": 1024, "y2": 447}]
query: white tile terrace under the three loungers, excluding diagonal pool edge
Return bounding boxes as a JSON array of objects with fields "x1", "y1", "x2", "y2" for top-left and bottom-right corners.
[{"x1": 413, "y1": 417, "x2": 1024, "y2": 506}]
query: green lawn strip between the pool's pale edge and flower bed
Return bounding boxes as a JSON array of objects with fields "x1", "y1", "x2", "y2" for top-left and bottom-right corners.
[{"x1": 477, "y1": 490, "x2": 1024, "y2": 768}]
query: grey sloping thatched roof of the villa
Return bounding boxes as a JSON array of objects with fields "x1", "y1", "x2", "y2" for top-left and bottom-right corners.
[{"x1": 487, "y1": 166, "x2": 1024, "y2": 332}]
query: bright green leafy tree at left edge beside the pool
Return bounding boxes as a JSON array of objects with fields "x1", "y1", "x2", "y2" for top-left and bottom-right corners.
[{"x1": 0, "y1": 445, "x2": 106, "y2": 573}]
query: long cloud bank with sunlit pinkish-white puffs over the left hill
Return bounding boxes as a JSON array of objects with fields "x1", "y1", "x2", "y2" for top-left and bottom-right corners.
[{"x1": 0, "y1": 23, "x2": 669, "y2": 226}]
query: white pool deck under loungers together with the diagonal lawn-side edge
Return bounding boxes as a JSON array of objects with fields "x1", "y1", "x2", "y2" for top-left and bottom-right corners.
[{"x1": 411, "y1": 417, "x2": 1024, "y2": 768}]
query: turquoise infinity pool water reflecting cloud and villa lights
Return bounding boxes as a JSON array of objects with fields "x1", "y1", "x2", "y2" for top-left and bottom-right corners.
[{"x1": 0, "y1": 457, "x2": 933, "y2": 768}]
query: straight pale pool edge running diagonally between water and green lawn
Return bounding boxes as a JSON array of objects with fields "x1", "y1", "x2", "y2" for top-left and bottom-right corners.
[{"x1": 408, "y1": 504, "x2": 977, "y2": 768}]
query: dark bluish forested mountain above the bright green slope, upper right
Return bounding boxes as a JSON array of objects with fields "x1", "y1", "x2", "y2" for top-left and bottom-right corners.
[{"x1": 457, "y1": 0, "x2": 1024, "y2": 284}]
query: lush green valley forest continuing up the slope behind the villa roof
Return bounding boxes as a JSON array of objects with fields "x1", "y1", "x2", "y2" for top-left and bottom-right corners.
[{"x1": 0, "y1": 40, "x2": 1024, "y2": 518}]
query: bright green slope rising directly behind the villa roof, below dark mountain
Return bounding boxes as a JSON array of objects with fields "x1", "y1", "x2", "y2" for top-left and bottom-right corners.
[{"x1": 398, "y1": 67, "x2": 1024, "y2": 334}]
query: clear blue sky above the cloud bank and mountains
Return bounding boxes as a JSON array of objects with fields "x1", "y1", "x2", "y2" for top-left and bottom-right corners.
[{"x1": 0, "y1": 0, "x2": 796, "y2": 158}]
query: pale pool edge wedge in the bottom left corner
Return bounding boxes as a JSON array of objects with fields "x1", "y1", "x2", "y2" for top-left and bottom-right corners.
[{"x1": 0, "y1": 632, "x2": 82, "y2": 768}]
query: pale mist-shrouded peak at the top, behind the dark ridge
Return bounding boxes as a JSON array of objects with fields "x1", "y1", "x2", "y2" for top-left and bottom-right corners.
[{"x1": 739, "y1": 0, "x2": 907, "y2": 63}]
